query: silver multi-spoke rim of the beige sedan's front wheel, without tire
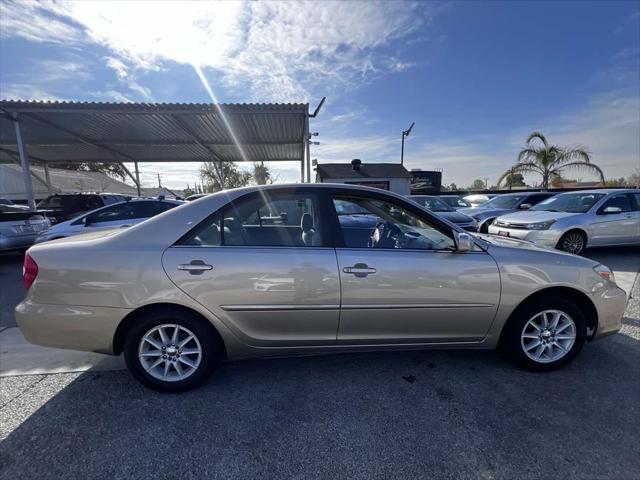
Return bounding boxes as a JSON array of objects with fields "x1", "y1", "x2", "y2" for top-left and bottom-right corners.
[{"x1": 520, "y1": 310, "x2": 576, "y2": 363}]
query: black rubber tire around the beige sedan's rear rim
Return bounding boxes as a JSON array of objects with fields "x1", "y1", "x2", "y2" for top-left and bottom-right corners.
[{"x1": 124, "y1": 308, "x2": 224, "y2": 393}]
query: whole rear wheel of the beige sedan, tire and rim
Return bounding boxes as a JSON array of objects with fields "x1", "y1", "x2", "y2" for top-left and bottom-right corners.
[{"x1": 124, "y1": 310, "x2": 222, "y2": 392}]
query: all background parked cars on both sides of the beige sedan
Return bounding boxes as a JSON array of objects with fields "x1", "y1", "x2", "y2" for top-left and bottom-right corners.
[{"x1": 0, "y1": 189, "x2": 640, "y2": 255}]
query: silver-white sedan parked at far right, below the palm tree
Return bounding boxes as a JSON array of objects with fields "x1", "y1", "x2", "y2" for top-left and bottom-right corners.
[{"x1": 489, "y1": 189, "x2": 640, "y2": 255}]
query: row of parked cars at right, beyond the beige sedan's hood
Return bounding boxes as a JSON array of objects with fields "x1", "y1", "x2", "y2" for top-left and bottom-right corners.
[{"x1": 409, "y1": 189, "x2": 640, "y2": 255}]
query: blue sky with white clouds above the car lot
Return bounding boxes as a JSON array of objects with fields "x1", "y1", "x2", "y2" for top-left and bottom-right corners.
[{"x1": 0, "y1": 0, "x2": 640, "y2": 188}]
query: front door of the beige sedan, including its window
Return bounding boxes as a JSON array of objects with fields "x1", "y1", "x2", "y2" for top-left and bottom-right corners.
[{"x1": 334, "y1": 194, "x2": 500, "y2": 344}]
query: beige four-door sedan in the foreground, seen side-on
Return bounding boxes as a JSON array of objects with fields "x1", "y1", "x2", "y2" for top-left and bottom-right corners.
[{"x1": 16, "y1": 183, "x2": 626, "y2": 391}]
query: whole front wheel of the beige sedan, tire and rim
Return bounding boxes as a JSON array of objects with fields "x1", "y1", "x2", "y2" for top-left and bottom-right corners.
[{"x1": 501, "y1": 297, "x2": 586, "y2": 371}]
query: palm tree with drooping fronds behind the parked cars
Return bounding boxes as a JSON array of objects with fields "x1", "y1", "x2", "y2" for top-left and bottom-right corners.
[{"x1": 497, "y1": 132, "x2": 604, "y2": 191}]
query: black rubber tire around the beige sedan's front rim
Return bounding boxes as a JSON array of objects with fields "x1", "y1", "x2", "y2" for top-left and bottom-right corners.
[{"x1": 500, "y1": 297, "x2": 587, "y2": 372}]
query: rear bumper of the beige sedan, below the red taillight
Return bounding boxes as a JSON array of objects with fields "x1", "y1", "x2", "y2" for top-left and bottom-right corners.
[{"x1": 15, "y1": 299, "x2": 131, "y2": 354}]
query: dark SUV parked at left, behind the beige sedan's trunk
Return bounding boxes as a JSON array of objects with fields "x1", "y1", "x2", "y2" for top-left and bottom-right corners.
[{"x1": 38, "y1": 193, "x2": 127, "y2": 224}]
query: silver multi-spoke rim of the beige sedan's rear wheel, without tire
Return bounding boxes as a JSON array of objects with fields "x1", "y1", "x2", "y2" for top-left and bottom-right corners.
[{"x1": 138, "y1": 323, "x2": 202, "y2": 382}]
